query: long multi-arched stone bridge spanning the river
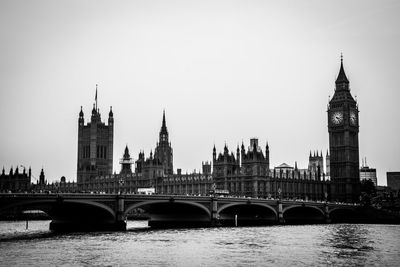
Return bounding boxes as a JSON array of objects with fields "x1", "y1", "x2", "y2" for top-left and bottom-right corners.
[{"x1": 0, "y1": 193, "x2": 358, "y2": 231}]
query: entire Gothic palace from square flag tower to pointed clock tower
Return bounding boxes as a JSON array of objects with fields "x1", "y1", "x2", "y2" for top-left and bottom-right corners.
[{"x1": 73, "y1": 59, "x2": 360, "y2": 202}]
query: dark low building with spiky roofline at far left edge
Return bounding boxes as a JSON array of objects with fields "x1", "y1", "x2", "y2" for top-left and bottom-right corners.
[{"x1": 0, "y1": 167, "x2": 32, "y2": 192}]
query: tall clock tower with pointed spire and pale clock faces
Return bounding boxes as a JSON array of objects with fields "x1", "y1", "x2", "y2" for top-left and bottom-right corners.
[{"x1": 328, "y1": 57, "x2": 360, "y2": 202}]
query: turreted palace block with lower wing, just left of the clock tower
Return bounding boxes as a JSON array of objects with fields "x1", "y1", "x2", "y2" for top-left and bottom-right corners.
[{"x1": 213, "y1": 138, "x2": 329, "y2": 200}]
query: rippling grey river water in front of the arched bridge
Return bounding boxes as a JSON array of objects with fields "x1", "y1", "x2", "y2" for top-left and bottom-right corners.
[{"x1": 0, "y1": 221, "x2": 400, "y2": 266}]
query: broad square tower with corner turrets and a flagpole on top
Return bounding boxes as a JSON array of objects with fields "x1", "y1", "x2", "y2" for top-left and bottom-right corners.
[{"x1": 77, "y1": 88, "x2": 114, "y2": 188}]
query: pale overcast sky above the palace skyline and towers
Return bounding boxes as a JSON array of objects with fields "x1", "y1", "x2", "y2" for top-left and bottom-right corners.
[{"x1": 0, "y1": 0, "x2": 400, "y2": 185}]
